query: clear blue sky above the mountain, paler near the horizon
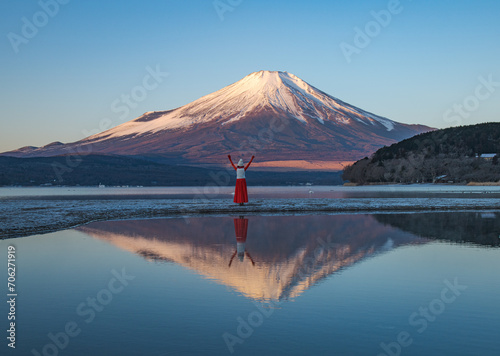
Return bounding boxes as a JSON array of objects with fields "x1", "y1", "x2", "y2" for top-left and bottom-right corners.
[{"x1": 0, "y1": 0, "x2": 500, "y2": 151}]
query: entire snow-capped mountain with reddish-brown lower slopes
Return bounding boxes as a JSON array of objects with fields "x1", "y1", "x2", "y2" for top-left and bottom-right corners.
[{"x1": 2, "y1": 71, "x2": 432, "y2": 169}]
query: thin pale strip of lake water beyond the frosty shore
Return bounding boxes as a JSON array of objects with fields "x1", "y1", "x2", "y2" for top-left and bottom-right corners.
[{"x1": 0, "y1": 184, "x2": 500, "y2": 200}]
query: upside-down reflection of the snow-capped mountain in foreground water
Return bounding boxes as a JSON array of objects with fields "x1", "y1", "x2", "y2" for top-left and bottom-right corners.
[{"x1": 78, "y1": 215, "x2": 427, "y2": 301}]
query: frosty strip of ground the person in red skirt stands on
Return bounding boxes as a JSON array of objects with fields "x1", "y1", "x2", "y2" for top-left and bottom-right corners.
[{"x1": 0, "y1": 197, "x2": 500, "y2": 239}]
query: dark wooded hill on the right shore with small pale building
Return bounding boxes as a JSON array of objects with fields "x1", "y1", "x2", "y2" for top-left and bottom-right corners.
[{"x1": 343, "y1": 123, "x2": 500, "y2": 184}]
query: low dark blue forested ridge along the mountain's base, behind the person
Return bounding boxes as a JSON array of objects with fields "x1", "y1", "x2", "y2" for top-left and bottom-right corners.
[{"x1": 0, "y1": 155, "x2": 342, "y2": 186}]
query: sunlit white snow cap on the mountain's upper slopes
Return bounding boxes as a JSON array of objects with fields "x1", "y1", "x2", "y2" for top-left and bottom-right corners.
[{"x1": 91, "y1": 71, "x2": 394, "y2": 140}]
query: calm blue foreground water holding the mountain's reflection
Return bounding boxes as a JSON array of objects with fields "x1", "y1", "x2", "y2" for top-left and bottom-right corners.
[{"x1": 0, "y1": 212, "x2": 500, "y2": 356}]
